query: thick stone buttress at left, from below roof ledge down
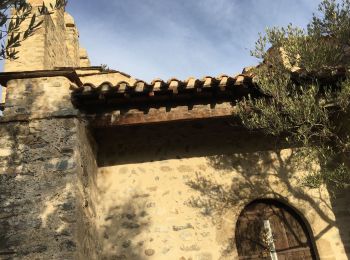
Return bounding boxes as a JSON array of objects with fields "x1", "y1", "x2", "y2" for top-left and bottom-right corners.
[{"x1": 0, "y1": 74, "x2": 99, "y2": 259}]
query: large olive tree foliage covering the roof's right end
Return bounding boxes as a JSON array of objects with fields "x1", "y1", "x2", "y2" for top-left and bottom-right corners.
[{"x1": 238, "y1": 0, "x2": 350, "y2": 188}]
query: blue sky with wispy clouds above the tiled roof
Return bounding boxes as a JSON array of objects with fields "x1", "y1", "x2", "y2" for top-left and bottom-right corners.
[{"x1": 0, "y1": 0, "x2": 320, "y2": 81}]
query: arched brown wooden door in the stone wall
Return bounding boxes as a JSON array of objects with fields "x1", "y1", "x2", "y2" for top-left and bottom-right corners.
[{"x1": 235, "y1": 200, "x2": 316, "y2": 260}]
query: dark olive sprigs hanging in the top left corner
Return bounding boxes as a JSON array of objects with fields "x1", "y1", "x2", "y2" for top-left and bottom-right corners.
[{"x1": 0, "y1": 0, "x2": 67, "y2": 60}]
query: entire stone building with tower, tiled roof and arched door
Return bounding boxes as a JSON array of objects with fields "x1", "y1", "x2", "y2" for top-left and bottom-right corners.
[{"x1": 0, "y1": 0, "x2": 350, "y2": 260}]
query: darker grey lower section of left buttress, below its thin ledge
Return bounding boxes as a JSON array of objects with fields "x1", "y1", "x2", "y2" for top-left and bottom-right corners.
[{"x1": 0, "y1": 119, "x2": 97, "y2": 259}]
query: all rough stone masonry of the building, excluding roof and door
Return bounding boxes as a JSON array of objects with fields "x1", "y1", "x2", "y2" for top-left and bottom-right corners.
[{"x1": 0, "y1": 0, "x2": 350, "y2": 260}]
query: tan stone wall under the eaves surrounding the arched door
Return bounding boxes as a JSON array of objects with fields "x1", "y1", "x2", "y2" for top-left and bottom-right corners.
[{"x1": 95, "y1": 120, "x2": 350, "y2": 260}]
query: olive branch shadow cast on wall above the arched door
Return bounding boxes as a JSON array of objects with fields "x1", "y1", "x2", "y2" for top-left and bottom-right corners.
[{"x1": 187, "y1": 150, "x2": 350, "y2": 254}]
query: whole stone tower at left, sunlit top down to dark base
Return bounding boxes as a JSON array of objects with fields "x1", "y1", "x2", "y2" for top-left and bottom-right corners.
[{"x1": 0, "y1": 0, "x2": 100, "y2": 259}]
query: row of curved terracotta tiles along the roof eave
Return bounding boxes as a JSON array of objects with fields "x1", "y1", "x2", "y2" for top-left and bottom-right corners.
[{"x1": 72, "y1": 74, "x2": 261, "y2": 113}]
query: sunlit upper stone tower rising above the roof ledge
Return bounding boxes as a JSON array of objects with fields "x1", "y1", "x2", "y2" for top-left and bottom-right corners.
[{"x1": 4, "y1": 0, "x2": 90, "y2": 72}]
